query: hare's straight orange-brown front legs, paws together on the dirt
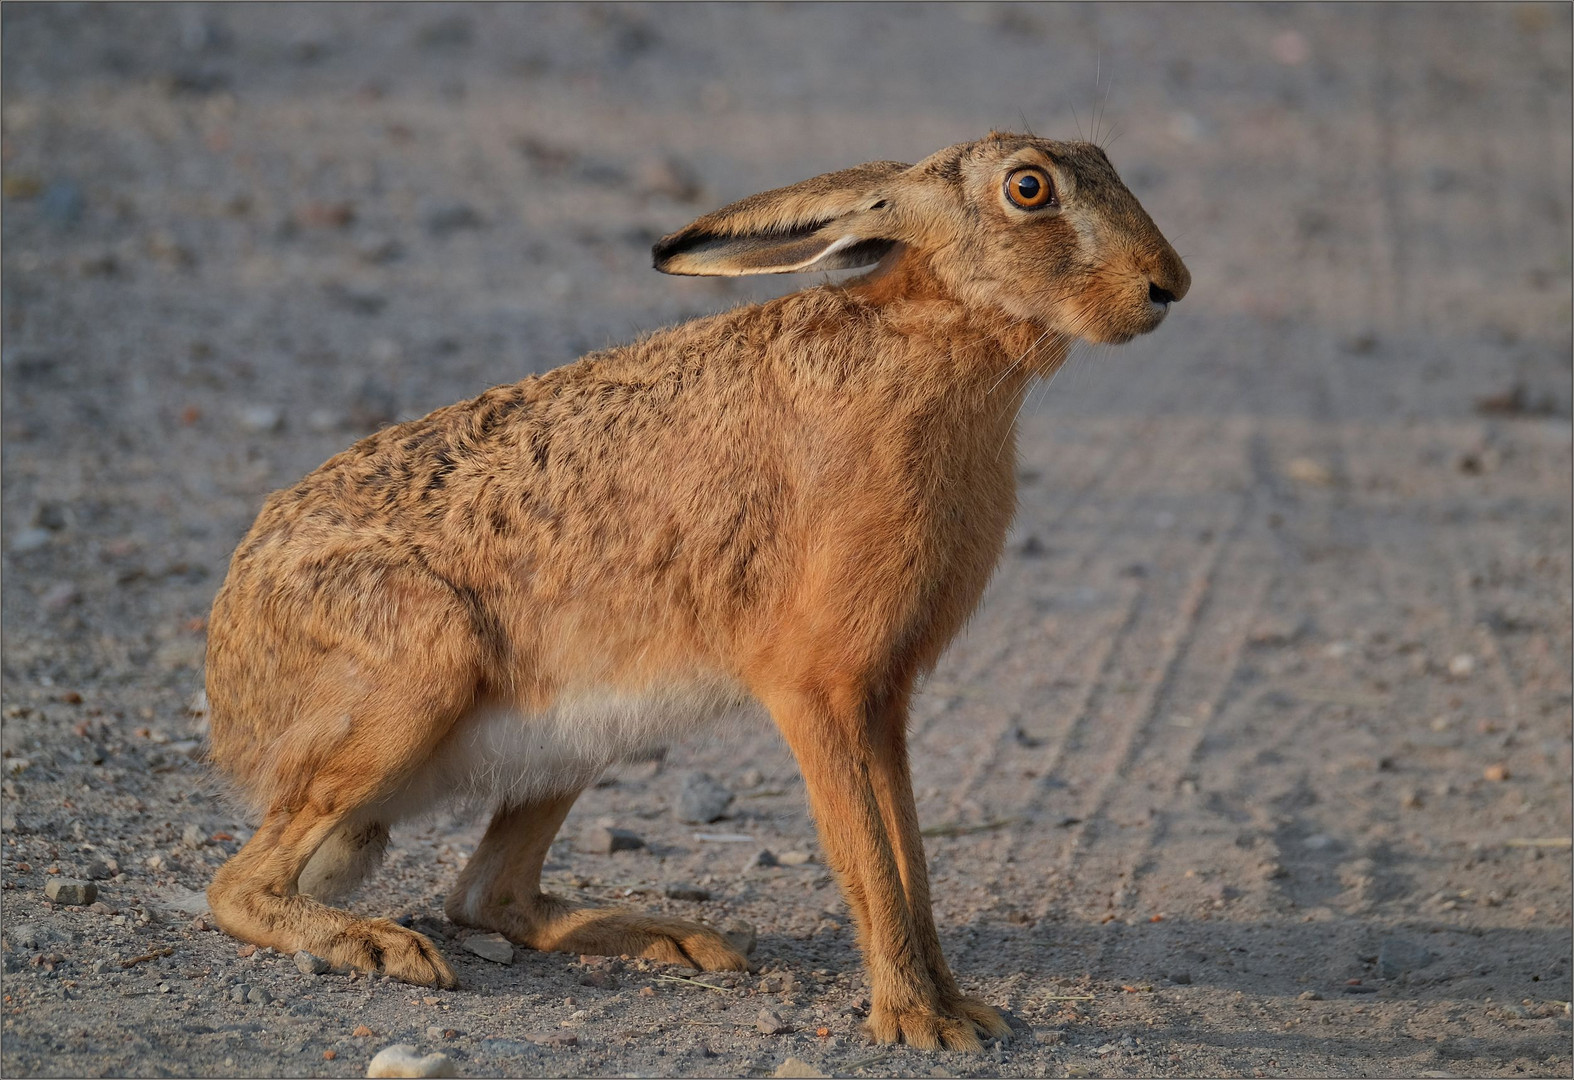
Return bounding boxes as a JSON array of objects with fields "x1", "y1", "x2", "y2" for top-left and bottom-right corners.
[{"x1": 771, "y1": 686, "x2": 1004, "y2": 1050}]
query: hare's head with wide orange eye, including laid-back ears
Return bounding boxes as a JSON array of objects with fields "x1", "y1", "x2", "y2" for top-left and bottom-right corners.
[{"x1": 655, "y1": 134, "x2": 1192, "y2": 343}]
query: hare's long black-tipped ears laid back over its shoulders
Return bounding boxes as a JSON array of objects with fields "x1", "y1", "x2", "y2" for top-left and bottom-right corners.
[{"x1": 652, "y1": 161, "x2": 911, "y2": 277}]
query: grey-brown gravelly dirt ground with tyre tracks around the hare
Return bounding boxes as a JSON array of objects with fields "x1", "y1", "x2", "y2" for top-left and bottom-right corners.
[{"x1": 0, "y1": 3, "x2": 1571, "y2": 1077}]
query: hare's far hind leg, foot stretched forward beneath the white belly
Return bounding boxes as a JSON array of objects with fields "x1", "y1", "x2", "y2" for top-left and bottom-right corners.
[{"x1": 447, "y1": 792, "x2": 748, "y2": 971}]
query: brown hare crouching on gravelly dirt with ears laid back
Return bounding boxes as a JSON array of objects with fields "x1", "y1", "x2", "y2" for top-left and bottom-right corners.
[{"x1": 208, "y1": 134, "x2": 1190, "y2": 1049}]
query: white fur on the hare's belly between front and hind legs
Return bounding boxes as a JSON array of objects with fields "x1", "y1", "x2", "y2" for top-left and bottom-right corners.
[{"x1": 378, "y1": 680, "x2": 759, "y2": 822}]
